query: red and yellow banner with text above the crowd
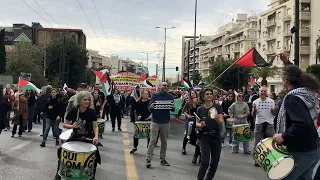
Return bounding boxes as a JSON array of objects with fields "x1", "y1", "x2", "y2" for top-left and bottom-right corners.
[{"x1": 110, "y1": 72, "x2": 158, "y2": 92}]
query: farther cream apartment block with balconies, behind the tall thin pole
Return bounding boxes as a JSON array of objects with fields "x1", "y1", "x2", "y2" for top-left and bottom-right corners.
[{"x1": 199, "y1": 14, "x2": 258, "y2": 77}]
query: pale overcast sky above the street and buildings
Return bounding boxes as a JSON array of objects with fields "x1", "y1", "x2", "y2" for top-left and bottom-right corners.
[{"x1": 0, "y1": 0, "x2": 269, "y2": 76}]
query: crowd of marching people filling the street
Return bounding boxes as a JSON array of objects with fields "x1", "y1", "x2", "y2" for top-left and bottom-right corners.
[{"x1": 0, "y1": 55, "x2": 320, "y2": 180}]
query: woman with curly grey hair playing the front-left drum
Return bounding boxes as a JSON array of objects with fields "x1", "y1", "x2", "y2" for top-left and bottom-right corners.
[{"x1": 56, "y1": 91, "x2": 101, "y2": 180}]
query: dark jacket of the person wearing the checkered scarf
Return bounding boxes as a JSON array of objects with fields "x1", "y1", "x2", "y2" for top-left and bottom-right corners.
[{"x1": 282, "y1": 95, "x2": 319, "y2": 152}]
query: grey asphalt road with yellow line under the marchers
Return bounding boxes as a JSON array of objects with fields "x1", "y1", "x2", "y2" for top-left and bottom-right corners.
[{"x1": 0, "y1": 116, "x2": 267, "y2": 180}]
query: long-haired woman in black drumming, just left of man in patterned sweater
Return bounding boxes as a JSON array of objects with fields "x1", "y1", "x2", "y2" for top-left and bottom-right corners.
[{"x1": 130, "y1": 89, "x2": 151, "y2": 154}]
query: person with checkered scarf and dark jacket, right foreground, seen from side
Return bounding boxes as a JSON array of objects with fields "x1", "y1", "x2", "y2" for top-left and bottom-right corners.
[{"x1": 273, "y1": 64, "x2": 320, "y2": 180}]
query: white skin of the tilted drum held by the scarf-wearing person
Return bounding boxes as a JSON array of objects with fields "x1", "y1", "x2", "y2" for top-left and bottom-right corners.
[{"x1": 268, "y1": 156, "x2": 294, "y2": 180}]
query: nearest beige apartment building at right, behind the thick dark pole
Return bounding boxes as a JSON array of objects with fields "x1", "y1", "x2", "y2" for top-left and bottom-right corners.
[{"x1": 256, "y1": 0, "x2": 320, "y2": 92}]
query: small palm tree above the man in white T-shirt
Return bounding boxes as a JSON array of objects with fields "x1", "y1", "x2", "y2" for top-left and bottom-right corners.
[{"x1": 250, "y1": 66, "x2": 278, "y2": 86}]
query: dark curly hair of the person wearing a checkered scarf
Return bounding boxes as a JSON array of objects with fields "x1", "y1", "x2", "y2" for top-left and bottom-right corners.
[{"x1": 282, "y1": 65, "x2": 320, "y2": 93}]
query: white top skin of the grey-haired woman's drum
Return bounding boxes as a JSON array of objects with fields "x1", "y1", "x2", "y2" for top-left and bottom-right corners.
[{"x1": 62, "y1": 141, "x2": 97, "y2": 153}]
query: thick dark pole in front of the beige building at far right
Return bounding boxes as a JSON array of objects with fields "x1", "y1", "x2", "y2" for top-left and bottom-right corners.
[{"x1": 294, "y1": 0, "x2": 300, "y2": 67}]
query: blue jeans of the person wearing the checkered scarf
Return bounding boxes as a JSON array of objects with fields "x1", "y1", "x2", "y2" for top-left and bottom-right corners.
[{"x1": 286, "y1": 149, "x2": 320, "y2": 180}]
